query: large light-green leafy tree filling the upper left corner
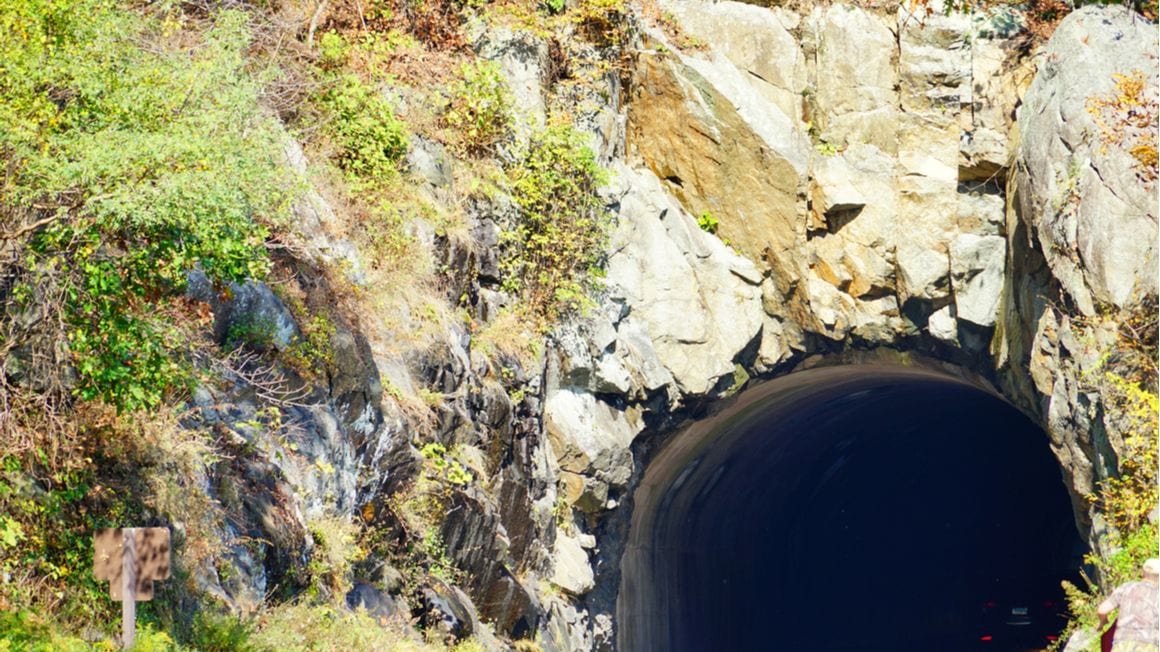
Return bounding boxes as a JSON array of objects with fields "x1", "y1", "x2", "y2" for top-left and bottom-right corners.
[{"x1": 0, "y1": 0, "x2": 288, "y2": 410}]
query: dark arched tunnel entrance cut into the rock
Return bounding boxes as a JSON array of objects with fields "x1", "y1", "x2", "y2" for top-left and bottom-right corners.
[{"x1": 617, "y1": 365, "x2": 1085, "y2": 652}]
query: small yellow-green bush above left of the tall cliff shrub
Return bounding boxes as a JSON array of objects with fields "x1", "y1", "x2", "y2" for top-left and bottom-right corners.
[{"x1": 442, "y1": 61, "x2": 514, "y2": 154}]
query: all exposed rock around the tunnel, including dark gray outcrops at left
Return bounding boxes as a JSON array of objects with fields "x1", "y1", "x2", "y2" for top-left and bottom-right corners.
[{"x1": 174, "y1": 0, "x2": 1157, "y2": 650}]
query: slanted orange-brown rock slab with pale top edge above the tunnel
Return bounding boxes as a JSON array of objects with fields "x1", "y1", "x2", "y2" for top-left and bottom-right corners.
[{"x1": 628, "y1": 53, "x2": 807, "y2": 293}]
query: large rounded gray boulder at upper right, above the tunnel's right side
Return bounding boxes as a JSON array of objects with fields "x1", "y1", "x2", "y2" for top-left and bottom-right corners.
[{"x1": 1017, "y1": 6, "x2": 1158, "y2": 314}]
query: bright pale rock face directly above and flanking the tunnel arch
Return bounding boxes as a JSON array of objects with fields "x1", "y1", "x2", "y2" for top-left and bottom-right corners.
[{"x1": 548, "y1": 5, "x2": 1157, "y2": 646}]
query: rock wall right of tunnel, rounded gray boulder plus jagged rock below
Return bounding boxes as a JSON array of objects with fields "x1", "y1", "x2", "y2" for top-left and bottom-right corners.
[{"x1": 995, "y1": 7, "x2": 1157, "y2": 548}]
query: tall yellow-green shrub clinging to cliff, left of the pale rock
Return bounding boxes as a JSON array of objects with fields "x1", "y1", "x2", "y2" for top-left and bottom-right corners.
[{"x1": 501, "y1": 124, "x2": 610, "y2": 323}]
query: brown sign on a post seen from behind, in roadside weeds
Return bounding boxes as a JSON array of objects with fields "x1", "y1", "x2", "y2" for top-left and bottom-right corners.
[{"x1": 93, "y1": 528, "x2": 169, "y2": 650}]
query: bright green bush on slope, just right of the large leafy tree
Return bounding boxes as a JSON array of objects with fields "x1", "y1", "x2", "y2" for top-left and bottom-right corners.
[{"x1": 320, "y1": 74, "x2": 407, "y2": 187}]
